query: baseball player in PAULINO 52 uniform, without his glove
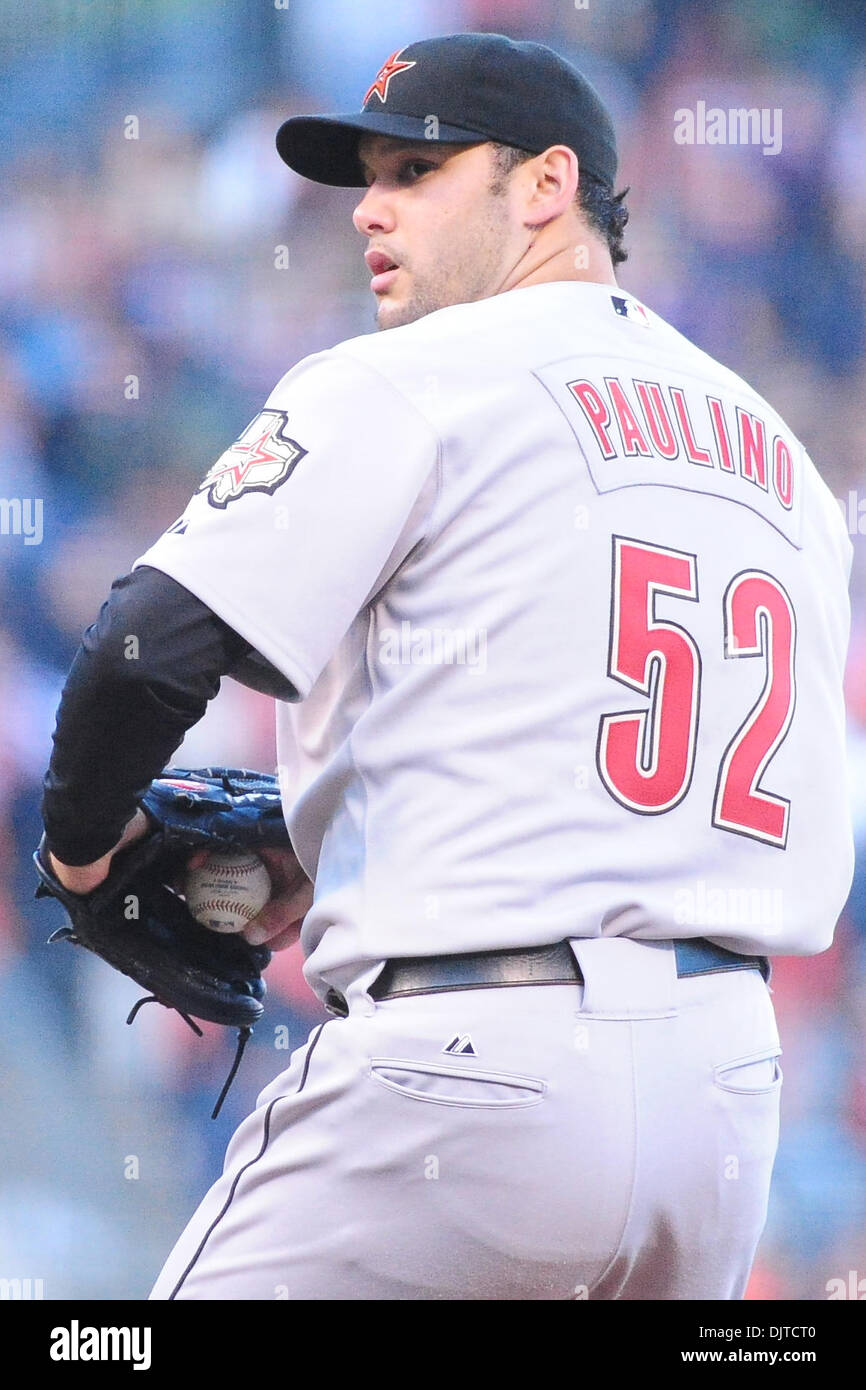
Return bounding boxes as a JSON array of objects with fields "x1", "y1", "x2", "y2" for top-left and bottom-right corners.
[{"x1": 44, "y1": 33, "x2": 852, "y2": 1300}]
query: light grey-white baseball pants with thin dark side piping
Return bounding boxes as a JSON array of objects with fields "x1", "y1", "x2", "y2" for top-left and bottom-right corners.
[{"x1": 150, "y1": 937, "x2": 781, "y2": 1300}]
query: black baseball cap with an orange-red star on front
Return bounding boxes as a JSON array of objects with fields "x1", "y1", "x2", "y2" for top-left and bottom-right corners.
[{"x1": 277, "y1": 33, "x2": 617, "y2": 188}]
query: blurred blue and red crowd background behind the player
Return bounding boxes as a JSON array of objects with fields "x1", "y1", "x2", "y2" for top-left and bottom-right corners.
[{"x1": 0, "y1": 0, "x2": 866, "y2": 1300}]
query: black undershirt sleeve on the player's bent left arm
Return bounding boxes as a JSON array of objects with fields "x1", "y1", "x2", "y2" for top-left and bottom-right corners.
[{"x1": 42, "y1": 566, "x2": 254, "y2": 865}]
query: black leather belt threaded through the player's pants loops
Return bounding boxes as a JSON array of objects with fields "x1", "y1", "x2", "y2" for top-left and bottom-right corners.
[{"x1": 325, "y1": 937, "x2": 770, "y2": 1017}]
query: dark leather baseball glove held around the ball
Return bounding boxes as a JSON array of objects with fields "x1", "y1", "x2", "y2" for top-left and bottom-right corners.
[{"x1": 33, "y1": 767, "x2": 291, "y2": 1118}]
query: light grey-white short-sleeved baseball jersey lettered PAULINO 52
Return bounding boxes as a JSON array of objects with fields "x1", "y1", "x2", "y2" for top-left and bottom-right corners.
[{"x1": 136, "y1": 281, "x2": 853, "y2": 995}]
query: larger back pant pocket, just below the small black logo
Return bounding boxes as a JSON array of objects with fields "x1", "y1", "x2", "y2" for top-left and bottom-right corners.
[{"x1": 368, "y1": 1056, "x2": 548, "y2": 1109}]
